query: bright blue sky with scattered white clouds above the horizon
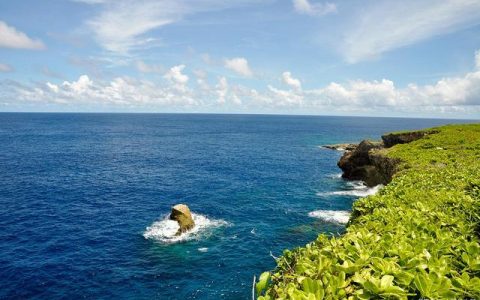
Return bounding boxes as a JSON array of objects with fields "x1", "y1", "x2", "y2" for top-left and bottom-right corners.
[{"x1": 0, "y1": 0, "x2": 480, "y2": 119}]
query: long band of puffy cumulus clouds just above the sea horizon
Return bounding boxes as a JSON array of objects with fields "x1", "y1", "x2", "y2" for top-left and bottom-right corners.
[{"x1": 5, "y1": 52, "x2": 480, "y2": 116}]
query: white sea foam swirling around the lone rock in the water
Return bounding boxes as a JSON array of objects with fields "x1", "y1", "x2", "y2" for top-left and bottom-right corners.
[{"x1": 143, "y1": 213, "x2": 230, "y2": 244}]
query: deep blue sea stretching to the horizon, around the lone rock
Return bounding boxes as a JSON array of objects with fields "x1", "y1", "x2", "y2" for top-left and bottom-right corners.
[{"x1": 0, "y1": 113, "x2": 472, "y2": 299}]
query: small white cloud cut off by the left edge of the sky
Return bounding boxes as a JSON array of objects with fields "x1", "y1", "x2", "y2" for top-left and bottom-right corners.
[{"x1": 0, "y1": 21, "x2": 46, "y2": 50}]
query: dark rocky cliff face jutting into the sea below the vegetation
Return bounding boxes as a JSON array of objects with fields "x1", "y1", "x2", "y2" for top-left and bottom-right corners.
[{"x1": 337, "y1": 131, "x2": 436, "y2": 187}]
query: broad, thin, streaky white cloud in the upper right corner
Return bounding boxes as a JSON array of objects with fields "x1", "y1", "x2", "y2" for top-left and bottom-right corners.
[{"x1": 340, "y1": 0, "x2": 480, "y2": 63}]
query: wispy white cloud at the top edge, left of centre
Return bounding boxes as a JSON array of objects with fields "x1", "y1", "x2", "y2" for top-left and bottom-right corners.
[{"x1": 76, "y1": 0, "x2": 263, "y2": 55}]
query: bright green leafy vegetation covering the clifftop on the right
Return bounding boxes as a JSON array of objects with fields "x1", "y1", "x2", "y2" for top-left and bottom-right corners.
[{"x1": 256, "y1": 124, "x2": 480, "y2": 299}]
